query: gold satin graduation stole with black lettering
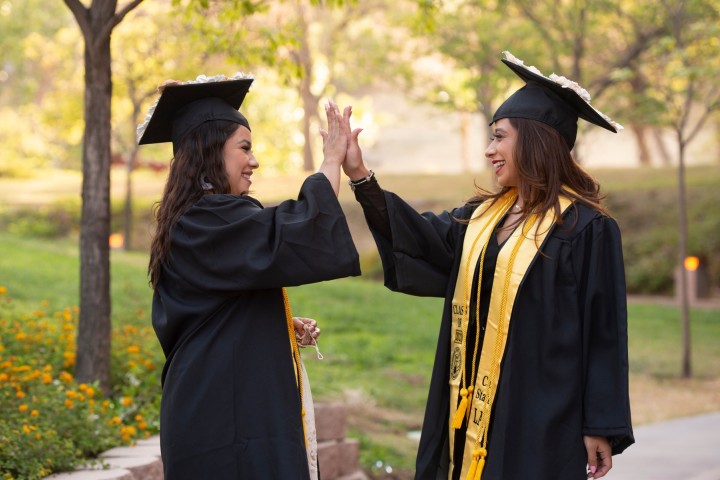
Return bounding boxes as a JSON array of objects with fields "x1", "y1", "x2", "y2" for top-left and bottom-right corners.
[{"x1": 448, "y1": 189, "x2": 572, "y2": 480}]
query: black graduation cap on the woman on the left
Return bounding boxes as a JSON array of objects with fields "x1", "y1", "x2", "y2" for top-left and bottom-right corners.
[{"x1": 137, "y1": 73, "x2": 253, "y2": 146}]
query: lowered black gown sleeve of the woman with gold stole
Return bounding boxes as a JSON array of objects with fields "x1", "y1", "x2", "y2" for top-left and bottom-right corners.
[{"x1": 572, "y1": 217, "x2": 634, "y2": 454}]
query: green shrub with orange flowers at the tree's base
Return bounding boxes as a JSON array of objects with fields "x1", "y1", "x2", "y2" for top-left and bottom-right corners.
[{"x1": 0, "y1": 286, "x2": 162, "y2": 480}]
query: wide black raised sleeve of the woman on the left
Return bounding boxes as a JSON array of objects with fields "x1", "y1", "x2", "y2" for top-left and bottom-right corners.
[{"x1": 164, "y1": 173, "x2": 360, "y2": 293}]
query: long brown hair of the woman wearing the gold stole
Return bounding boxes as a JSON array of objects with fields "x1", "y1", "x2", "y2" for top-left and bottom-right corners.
[{"x1": 469, "y1": 118, "x2": 608, "y2": 223}]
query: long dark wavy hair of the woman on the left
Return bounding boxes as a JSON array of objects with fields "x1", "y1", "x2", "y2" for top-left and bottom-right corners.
[{"x1": 148, "y1": 120, "x2": 240, "y2": 289}]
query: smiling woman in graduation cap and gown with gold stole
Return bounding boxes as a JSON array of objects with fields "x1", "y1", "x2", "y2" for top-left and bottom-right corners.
[{"x1": 343, "y1": 52, "x2": 634, "y2": 480}]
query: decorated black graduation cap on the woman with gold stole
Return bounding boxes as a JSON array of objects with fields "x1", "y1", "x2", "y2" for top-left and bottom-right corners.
[{"x1": 490, "y1": 51, "x2": 623, "y2": 150}]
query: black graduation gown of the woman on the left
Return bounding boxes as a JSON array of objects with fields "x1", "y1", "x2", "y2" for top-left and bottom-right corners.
[{"x1": 152, "y1": 174, "x2": 360, "y2": 480}]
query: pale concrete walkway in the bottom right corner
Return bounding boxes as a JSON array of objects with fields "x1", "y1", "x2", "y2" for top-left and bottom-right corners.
[{"x1": 605, "y1": 412, "x2": 720, "y2": 480}]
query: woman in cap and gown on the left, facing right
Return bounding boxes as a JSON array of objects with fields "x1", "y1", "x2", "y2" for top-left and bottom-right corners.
[{"x1": 138, "y1": 75, "x2": 360, "y2": 480}]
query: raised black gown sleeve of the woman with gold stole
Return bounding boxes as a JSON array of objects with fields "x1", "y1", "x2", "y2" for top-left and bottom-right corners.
[{"x1": 355, "y1": 181, "x2": 463, "y2": 297}]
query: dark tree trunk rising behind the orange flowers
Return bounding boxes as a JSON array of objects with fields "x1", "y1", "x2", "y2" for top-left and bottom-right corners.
[{"x1": 75, "y1": 7, "x2": 114, "y2": 393}]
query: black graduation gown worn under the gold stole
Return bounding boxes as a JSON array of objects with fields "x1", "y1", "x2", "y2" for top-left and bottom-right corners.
[{"x1": 356, "y1": 185, "x2": 634, "y2": 480}]
